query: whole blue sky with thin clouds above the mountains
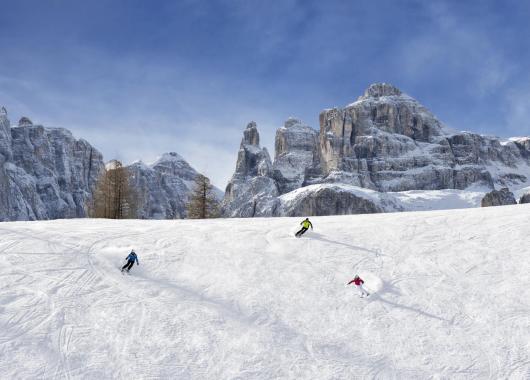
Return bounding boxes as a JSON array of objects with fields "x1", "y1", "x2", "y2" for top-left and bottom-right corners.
[{"x1": 0, "y1": 0, "x2": 530, "y2": 189}]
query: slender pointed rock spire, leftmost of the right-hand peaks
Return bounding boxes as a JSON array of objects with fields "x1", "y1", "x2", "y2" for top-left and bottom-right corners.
[{"x1": 221, "y1": 122, "x2": 279, "y2": 217}]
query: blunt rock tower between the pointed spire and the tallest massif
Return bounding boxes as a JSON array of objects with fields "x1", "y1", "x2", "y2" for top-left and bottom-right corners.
[{"x1": 273, "y1": 118, "x2": 319, "y2": 194}]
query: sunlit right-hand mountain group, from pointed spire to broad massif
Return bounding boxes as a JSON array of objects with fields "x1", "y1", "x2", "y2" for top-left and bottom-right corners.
[{"x1": 223, "y1": 83, "x2": 530, "y2": 216}]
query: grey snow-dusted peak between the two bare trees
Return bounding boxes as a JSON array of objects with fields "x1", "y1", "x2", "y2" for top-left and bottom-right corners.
[{"x1": 128, "y1": 152, "x2": 221, "y2": 219}]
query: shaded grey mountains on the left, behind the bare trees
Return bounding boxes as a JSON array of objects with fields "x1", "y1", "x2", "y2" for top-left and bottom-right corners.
[{"x1": 0, "y1": 107, "x2": 222, "y2": 221}]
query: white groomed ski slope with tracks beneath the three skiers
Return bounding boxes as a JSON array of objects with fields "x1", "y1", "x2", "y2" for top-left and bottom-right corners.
[{"x1": 0, "y1": 205, "x2": 530, "y2": 379}]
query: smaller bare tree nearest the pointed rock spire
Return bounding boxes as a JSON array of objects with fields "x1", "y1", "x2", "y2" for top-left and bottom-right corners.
[{"x1": 187, "y1": 174, "x2": 219, "y2": 219}]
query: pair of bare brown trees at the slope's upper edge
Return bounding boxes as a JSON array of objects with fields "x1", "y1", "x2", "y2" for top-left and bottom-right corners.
[{"x1": 87, "y1": 160, "x2": 220, "y2": 219}]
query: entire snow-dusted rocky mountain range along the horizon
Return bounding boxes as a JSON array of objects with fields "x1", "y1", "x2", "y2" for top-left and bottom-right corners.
[{"x1": 0, "y1": 83, "x2": 530, "y2": 221}]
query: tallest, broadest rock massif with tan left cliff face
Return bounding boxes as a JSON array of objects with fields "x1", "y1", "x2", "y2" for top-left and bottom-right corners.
[{"x1": 319, "y1": 84, "x2": 528, "y2": 191}]
